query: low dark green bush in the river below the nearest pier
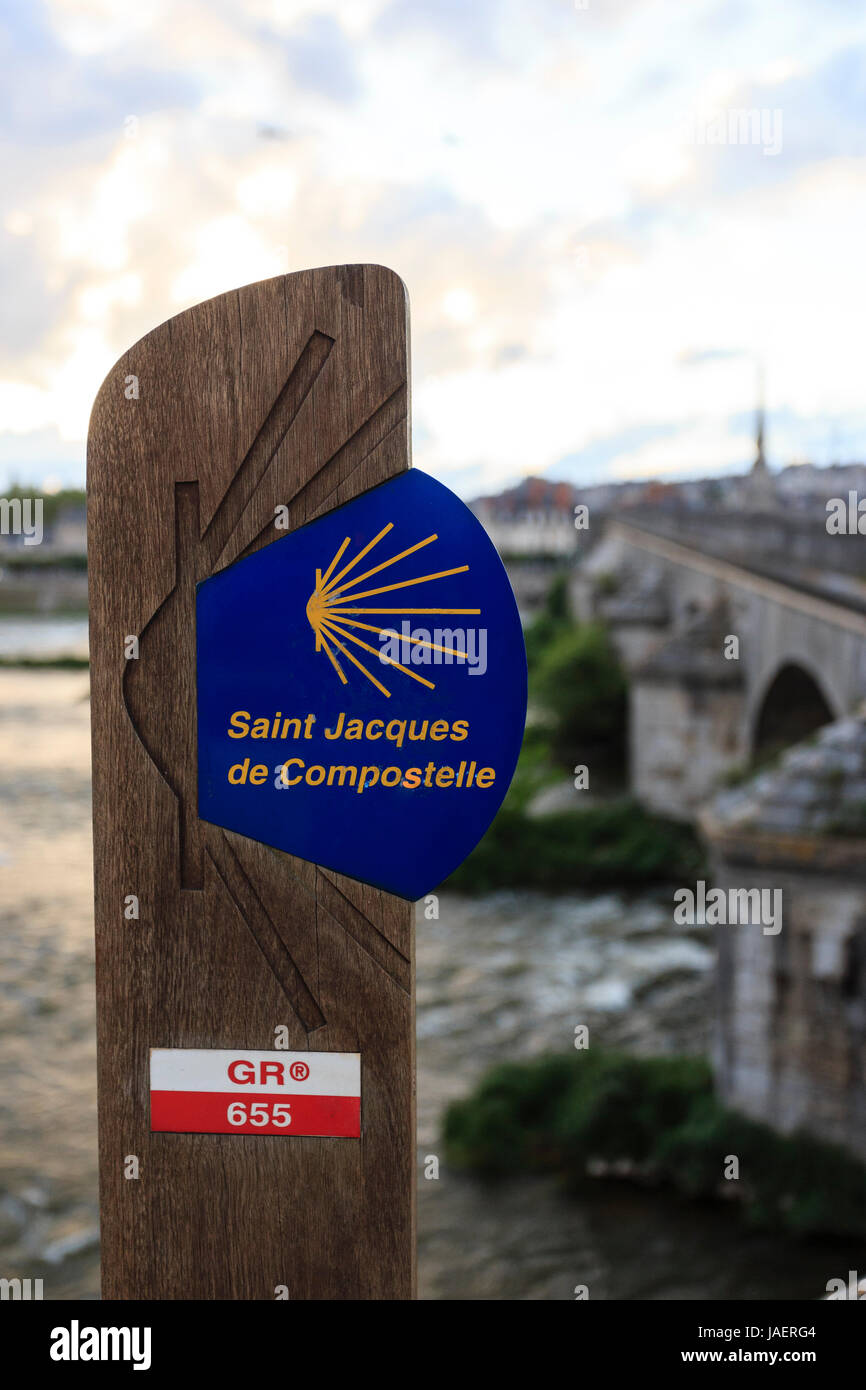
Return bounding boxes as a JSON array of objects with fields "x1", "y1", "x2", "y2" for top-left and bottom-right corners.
[{"x1": 443, "y1": 1047, "x2": 866, "y2": 1236}]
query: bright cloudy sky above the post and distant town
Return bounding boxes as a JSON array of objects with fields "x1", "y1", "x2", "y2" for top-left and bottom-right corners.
[{"x1": 0, "y1": 0, "x2": 866, "y2": 496}]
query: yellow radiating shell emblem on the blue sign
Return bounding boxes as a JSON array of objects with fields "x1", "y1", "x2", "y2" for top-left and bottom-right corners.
[{"x1": 307, "y1": 521, "x2": 481, "y2": 699}]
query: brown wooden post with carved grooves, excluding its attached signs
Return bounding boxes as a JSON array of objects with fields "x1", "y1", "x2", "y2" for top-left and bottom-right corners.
[{"x1": 88, "y1": 265, "x2": 416, "y2": 1300}]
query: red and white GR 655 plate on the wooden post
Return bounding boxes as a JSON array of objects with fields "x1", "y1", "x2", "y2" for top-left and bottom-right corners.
[{"x1": 150, "y1": 1048, "x2": 361, "y2": 1138}]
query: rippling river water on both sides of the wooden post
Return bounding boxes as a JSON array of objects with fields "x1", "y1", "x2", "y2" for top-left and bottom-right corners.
[{"x1": 0, "y1": 670, "x2": 862, "y2": 1300}]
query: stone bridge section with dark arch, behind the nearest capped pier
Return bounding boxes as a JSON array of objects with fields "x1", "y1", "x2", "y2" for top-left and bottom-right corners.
[{"x1": 571, "y1": 514, "x2": 866, "y2": 817}]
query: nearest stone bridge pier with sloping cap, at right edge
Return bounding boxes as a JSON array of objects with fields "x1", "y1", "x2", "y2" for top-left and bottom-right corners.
[{"x1": 701, "y1": 719, "x2": 866, "y2": 1159}]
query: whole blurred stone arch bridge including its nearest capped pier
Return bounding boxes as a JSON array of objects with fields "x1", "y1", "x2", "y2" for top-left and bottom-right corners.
[{"x1": 571, "y1": 509, "x2": 866, "y2": 1161}]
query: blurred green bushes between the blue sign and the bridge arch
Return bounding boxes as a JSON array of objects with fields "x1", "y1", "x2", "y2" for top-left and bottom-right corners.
[{"x1": 448, "y1": 575, "x2": 705, "y2": 892}]
